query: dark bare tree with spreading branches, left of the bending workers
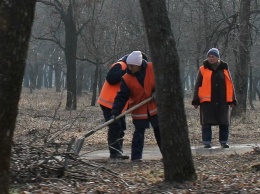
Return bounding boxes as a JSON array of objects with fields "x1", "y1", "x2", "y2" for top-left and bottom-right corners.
[{"x1": 37, "y1": 0, "x2": 89, "y2": 110}]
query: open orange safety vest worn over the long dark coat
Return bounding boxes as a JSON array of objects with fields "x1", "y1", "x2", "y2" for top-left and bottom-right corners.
[{"x1": 198, "y1": 66, "x2": 234, "y2": 103}]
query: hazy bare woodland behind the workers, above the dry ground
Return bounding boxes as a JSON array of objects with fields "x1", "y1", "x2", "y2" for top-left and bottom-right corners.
[{"x1": 23, "y1": 0, "x2": 260, "y2": 109}]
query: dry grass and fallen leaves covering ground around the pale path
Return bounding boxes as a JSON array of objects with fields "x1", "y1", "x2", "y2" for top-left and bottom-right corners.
[{"x1": 12, "y1": 89, "x2": 260, "y2": 194}]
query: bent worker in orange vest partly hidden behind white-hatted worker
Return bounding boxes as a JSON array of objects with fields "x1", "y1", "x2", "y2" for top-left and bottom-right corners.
[{"x1": 97, "y1": 55, "x2": 129, "y2": 159}]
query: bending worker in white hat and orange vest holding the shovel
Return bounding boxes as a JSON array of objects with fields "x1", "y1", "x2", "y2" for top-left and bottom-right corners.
[{"x1": 111, "y1": 51, "x2": 161, "y2": 162}]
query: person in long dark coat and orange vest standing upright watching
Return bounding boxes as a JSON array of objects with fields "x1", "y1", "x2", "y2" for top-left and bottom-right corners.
[{"x1": 192, "y1": 48, "x2": 237, "y2": 148}]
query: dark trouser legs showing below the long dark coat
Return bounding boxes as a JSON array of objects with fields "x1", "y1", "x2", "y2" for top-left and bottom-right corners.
[{"x1": 202, "y1": 125, "x2": 229, "y2": 144}]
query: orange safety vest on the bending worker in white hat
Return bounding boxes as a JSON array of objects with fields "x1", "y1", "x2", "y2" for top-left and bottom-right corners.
[{"x1": 123, "y1": 62, "x2": 157, "y2": 119}]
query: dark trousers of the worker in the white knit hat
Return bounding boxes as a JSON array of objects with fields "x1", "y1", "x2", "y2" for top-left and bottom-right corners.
[{"x1": 131, "y1": 115, "x2": 161, "y2": 160}]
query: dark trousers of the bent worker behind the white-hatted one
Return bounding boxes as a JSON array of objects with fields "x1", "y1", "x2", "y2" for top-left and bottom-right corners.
[{"x1": 100, "y1": 105, "x2": 126, "y2": 155}]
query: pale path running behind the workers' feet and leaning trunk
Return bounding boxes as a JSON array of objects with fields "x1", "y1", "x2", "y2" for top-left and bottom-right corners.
[{"x1": 80, "y1": 143, "x2": 260, "y2": 160}]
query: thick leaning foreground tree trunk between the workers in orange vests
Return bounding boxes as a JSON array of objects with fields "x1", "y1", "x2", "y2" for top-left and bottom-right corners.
[{"x1": 140, "y1": 0, "x2": 196, "y2": 182}]
